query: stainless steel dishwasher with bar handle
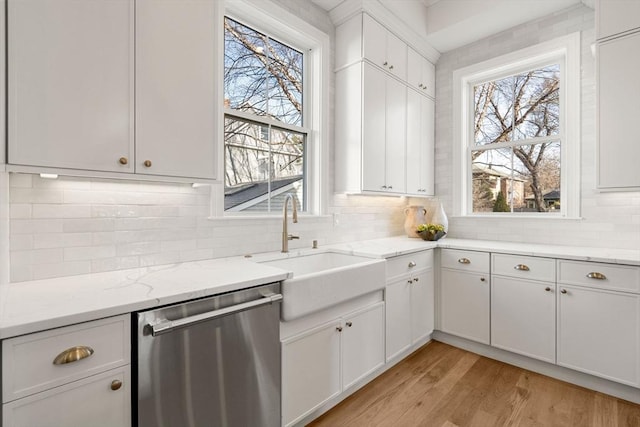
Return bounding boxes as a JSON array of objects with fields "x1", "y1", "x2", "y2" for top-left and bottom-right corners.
[{"x1": 136, "y1": 283, "x2": 282, "y2": 427}]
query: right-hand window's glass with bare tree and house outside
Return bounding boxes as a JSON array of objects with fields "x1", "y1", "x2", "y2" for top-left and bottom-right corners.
[{"x1": 467, "y1": 63, "x2": 562, "y2": 213}]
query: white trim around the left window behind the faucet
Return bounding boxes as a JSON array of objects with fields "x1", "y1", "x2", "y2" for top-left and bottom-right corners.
[{"x1": 211, "y1": 0, "x2": 331, "y2": 219}]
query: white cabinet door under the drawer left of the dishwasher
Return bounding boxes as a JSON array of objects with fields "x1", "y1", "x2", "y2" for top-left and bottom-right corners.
[{"x1": 2, "y1": 365, "x2": 131, "y2": 427}]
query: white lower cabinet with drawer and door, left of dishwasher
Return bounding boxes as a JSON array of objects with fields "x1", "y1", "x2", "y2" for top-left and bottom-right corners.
[{"x1": 2, "y1": 315, "x2": 131, "y2": 427}]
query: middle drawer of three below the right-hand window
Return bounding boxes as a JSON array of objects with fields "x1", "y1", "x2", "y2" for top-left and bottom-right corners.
[{"x1": 491, "y1": 254, "x2": 556, "y2": 282}]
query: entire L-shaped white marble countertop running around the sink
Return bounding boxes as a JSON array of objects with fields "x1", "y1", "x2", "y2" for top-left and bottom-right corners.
[{"x1": 0, "y1": 236, "x2": 640, "y2": 339}]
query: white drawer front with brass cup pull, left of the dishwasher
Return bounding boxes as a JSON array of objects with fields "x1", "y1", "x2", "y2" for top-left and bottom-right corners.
[{"x1": 2, "y1": 314, "x2": 131, "y2": 402}]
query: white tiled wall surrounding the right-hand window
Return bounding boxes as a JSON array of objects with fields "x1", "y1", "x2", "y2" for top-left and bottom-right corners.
[{"x1": 436, "y1": 6, "x2": 640, "y2": 249}]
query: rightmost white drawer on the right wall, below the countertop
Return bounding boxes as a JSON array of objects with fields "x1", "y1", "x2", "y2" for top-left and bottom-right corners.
[{"x1": 558, "y1": 260, "x2": 640, "y2": 292}]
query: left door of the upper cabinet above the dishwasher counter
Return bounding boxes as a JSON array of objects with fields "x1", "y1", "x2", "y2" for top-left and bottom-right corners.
[{"x1": 7, "y1": 0, "x2": 134, "y2": 172}]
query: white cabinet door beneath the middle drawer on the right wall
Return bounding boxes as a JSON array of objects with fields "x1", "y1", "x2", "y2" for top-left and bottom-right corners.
[{"x1": 491, "y1": 276, "x2": 556, "y2": 363}]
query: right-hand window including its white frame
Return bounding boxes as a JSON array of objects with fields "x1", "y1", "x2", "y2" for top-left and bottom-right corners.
[{"x1": 454, "y1": 34, "x2": 580, "y2": 217}]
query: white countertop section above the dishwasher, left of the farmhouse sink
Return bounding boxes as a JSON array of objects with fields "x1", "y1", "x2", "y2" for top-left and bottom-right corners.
[{"x1": 0, "y1": 258, "x2": 290, "y2": 339}]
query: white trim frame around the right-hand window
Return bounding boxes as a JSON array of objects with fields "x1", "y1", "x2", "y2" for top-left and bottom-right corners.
[{"x1": 452, "y1": 32, "x2": 582, "y2": 219}]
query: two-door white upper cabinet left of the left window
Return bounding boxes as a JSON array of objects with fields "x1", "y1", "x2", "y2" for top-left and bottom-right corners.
[{"x1": 8, "y1": 0, "x2": 222, "y2": 180}]
